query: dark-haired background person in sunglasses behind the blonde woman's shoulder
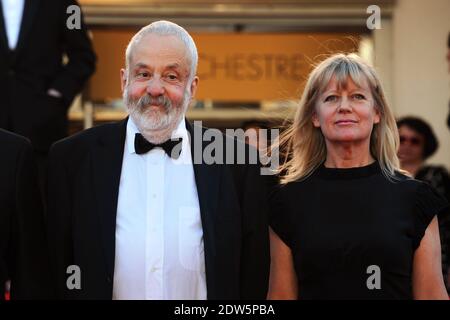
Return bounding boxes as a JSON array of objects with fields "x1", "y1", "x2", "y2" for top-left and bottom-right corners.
[{"x1": 397, "y1": 117, "x2": 450, "y2": 291}]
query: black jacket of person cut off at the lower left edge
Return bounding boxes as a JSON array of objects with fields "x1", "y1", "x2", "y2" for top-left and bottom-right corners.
[{"x1": 0, "y1": 129, "x2": 51, "y2": 300}]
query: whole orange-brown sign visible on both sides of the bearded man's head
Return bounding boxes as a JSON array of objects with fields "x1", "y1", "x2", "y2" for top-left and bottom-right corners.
[{"x1": 91, "y1": 30, "x2": 360, "y2": 102}]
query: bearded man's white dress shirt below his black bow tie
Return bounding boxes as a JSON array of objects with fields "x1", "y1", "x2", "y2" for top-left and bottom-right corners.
[{"x1": 113, "y1": 118, "x2": 207, "y2": 300}]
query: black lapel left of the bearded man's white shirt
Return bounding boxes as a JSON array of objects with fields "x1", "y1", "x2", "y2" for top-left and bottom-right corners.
[{"x1": 92, "y1": 118, "x2": 128, "y2": 279}]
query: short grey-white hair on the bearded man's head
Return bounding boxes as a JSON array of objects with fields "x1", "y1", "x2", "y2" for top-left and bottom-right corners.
[{"x1": 125, "y1": 20, "x2": 198, "y2": 81}]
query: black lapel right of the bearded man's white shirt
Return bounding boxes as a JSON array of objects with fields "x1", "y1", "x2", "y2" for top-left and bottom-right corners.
[{"x1": 186, "y1": 121, "x2": 221, "y2": 299}]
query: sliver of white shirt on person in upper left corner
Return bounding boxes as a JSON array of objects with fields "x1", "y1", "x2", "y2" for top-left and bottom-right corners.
[{"x1": 1, "y1": 0, "x2": 25, "y2": 50}]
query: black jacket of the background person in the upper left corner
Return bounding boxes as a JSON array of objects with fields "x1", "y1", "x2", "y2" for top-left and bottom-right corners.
[{"x1": 0, "y1": 0, "x2": 96, "y2": 152}]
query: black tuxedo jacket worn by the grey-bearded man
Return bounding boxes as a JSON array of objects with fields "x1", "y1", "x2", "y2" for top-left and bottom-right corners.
[{"x1": 48, "y1": 120, "x2": 270, "y2": 299}]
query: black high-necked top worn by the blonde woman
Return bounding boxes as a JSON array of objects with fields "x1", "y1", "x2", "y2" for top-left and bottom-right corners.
[{"x1": 270, "y1": 162, "x2": 448, "y2": 299}]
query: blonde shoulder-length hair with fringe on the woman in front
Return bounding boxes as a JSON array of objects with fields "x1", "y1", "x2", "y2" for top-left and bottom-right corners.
[{"x1": 272, "y1": 53, "x2": 401, "y2": 184}]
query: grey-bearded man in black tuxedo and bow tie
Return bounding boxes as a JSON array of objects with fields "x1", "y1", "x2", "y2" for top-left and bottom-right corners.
[{"x1": 48, "y1": 21, "x2": 270, "y2": 300}]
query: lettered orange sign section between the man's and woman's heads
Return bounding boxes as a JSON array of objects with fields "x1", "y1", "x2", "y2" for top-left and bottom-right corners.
[{"x1": 194, "y1": 33, "x2": 359, "y2": 101}]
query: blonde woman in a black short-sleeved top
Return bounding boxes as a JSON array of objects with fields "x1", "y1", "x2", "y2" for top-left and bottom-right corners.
[{"x1": 268, "y1": 54, "x2": 448, "y2": 299}]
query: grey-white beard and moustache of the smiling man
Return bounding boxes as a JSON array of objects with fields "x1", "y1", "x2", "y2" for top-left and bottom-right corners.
[{"x1": 123, "y1": 88, "x2": 190, "y2": 143}]
